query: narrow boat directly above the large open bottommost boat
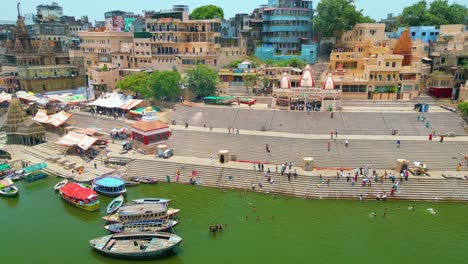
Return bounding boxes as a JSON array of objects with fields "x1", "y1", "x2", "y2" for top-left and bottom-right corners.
[{"x1": 104, "y1": 219, "x2": 178, "y2": 233}]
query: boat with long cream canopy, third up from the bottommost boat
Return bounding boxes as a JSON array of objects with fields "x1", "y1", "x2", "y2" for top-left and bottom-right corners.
[{"x1": 102, "y1": 203, "x2": 180, "y2": 223}]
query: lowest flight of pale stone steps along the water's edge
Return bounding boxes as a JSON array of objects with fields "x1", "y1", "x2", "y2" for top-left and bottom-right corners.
[{"x1": 123, "y1": 160, "x2": 468, "y2": 200}]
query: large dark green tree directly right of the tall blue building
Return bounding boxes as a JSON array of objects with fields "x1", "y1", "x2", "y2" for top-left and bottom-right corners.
[{"x1": 313, "y1": 0, "x2": 375, "y2": 37}]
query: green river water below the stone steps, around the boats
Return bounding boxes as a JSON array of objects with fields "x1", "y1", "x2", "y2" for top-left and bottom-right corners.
[{"x1": 0, "y1": 177, "x2": 468, "y2": 264}]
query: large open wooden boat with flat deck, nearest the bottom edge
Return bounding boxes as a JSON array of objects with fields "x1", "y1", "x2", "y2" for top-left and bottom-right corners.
[{"x1": 89, "y1": 232, "x2": 182, "y2": 258}]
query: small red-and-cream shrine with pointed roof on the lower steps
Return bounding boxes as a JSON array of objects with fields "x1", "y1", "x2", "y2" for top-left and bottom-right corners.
[{"x1": 132, "y1": 107, "x2": 171, "y2": 146}]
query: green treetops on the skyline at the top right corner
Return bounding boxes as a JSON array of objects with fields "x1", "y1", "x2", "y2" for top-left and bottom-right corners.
[{"x1": 400, "y1": 0, "x2": 468, "y2": 26}]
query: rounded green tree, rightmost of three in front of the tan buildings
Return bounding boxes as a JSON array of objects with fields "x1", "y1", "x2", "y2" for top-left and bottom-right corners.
[{"x1": 187, "y1": 64, "x2": 219, "y2": 98}]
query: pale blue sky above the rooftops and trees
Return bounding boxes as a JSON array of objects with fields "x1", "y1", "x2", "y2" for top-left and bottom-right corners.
[{"x1": 0, "y1": 0, "x2": 466, "y2": 21}]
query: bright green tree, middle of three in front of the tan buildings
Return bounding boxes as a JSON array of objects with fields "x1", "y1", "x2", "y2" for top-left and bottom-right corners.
[{"x1": 146, "y1": 71, "x2": 182, "y2": 99}]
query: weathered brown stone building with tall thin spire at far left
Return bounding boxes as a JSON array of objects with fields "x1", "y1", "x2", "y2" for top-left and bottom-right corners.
[{"x1": 5, "y1": 4, "x2": 84, "y2": 93}]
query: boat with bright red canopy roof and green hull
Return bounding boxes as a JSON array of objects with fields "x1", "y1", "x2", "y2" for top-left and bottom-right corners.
[{"x1": 59, "y1": 182, "x2": 100, "y2": 211}]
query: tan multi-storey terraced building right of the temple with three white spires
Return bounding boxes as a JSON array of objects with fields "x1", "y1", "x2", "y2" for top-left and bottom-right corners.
[{"x1": 324, "y1": 23, "x2": 427, "y2": 100}]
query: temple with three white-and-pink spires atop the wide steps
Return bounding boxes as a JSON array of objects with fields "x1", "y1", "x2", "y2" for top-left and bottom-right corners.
[{"x1": 273, "y1": 65, "x2": 341, "y2": 112}]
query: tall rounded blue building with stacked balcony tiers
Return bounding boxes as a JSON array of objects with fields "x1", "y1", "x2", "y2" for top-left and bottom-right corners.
[{"x1": 255, "y1": 0, "x2": 319, "y2": 63}]
